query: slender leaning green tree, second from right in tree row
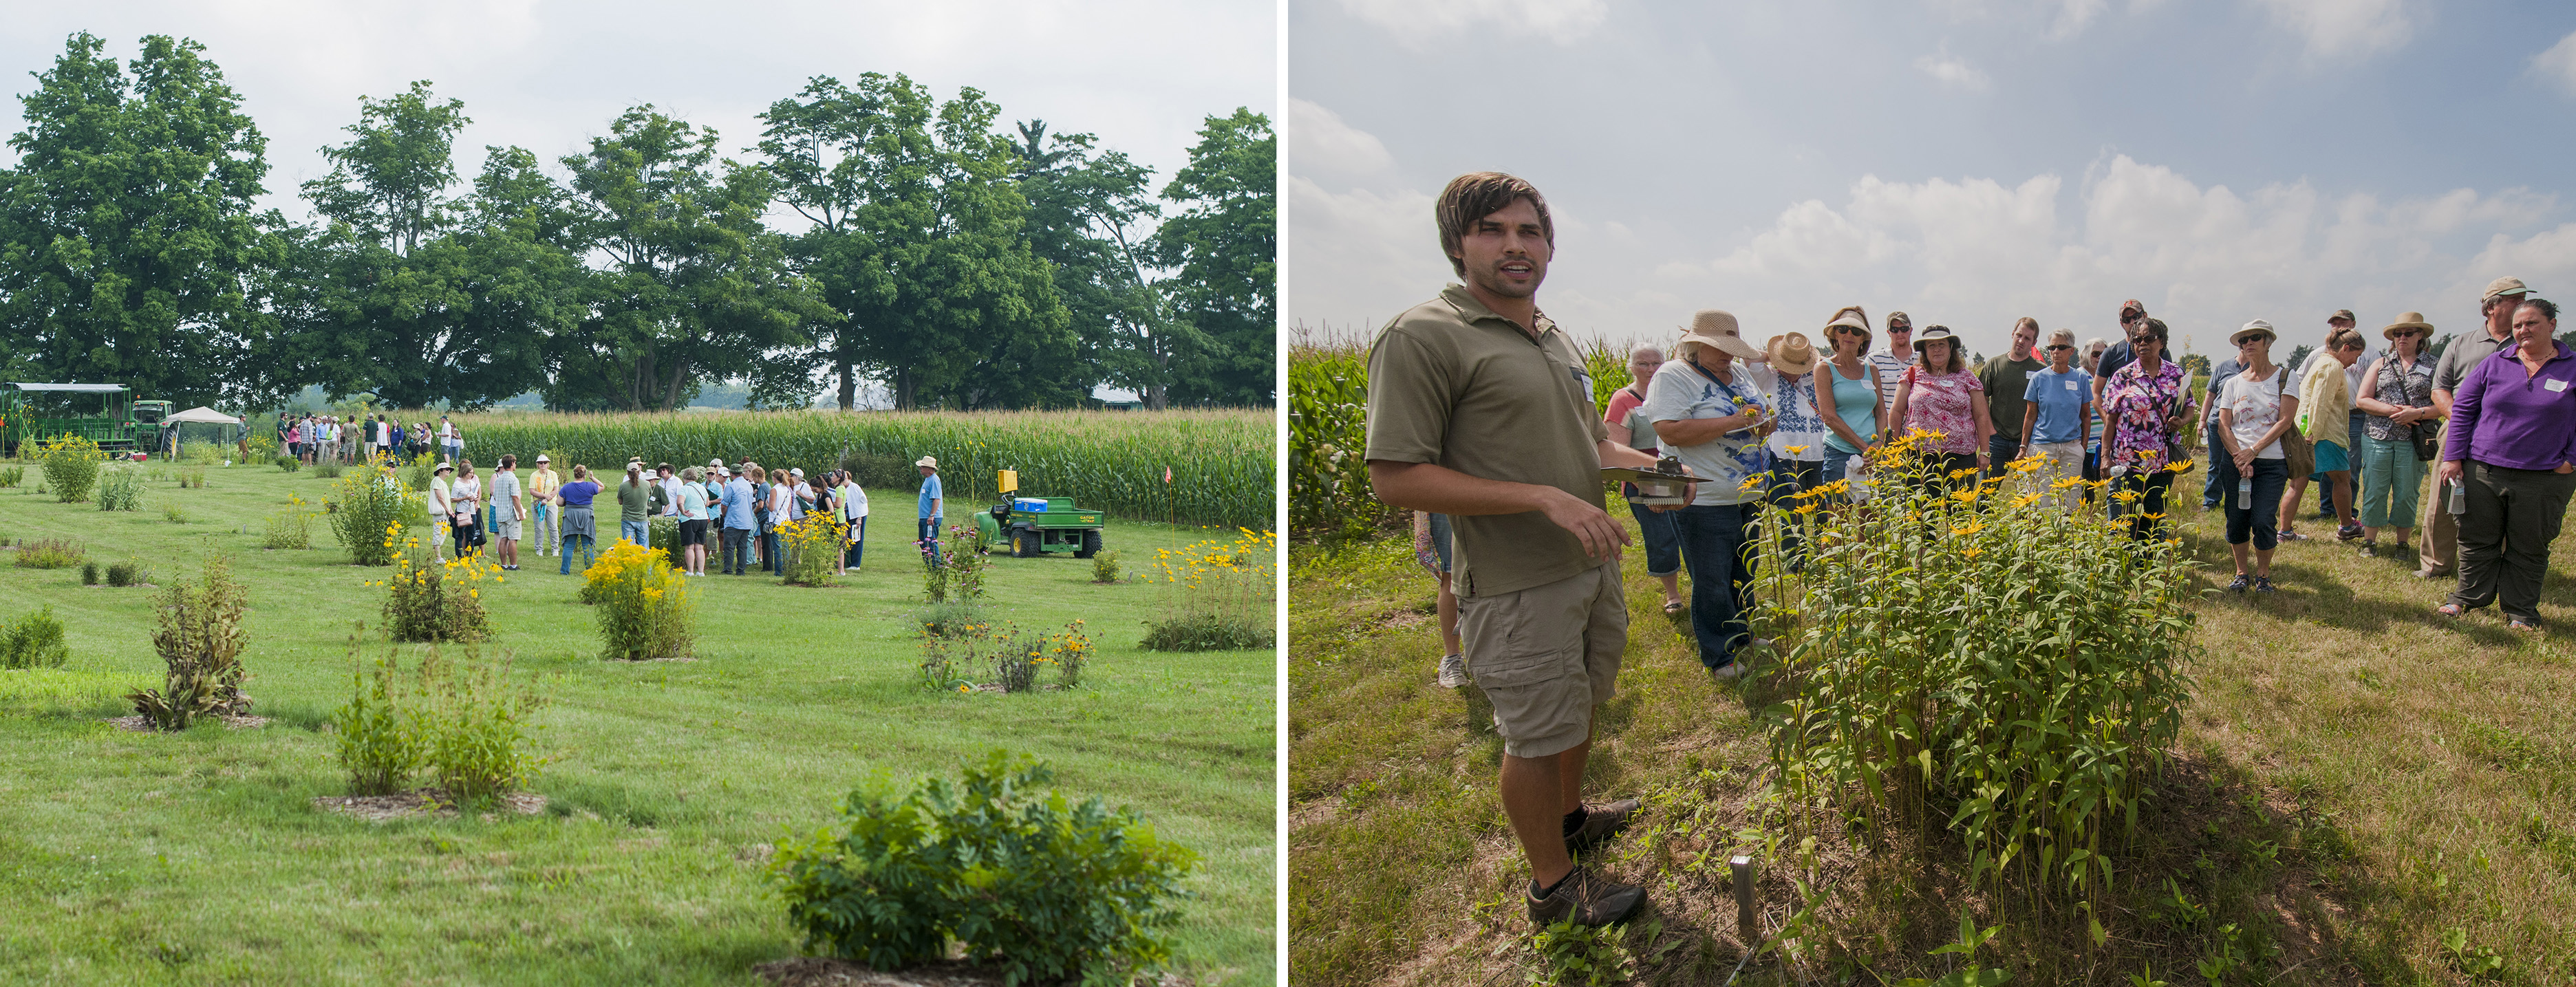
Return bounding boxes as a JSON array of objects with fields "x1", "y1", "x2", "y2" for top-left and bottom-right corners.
[{"x1": 1012, "y1": 121, "x2": 1208, "y2": 410}]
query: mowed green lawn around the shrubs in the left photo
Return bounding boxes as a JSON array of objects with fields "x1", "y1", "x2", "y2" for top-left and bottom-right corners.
[{"x1": 0, "y1": 466, "x2": 1275, "y2": 984}]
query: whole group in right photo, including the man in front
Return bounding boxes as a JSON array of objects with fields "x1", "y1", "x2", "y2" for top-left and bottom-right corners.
[{"x1": 1365, "y1": 173, "x2": 2576, "y2": 925}]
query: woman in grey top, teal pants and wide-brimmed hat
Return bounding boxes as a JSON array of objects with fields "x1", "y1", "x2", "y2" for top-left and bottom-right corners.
[{"x1": 2352, "y1": 312, "x2": 2437, "y2": 556}]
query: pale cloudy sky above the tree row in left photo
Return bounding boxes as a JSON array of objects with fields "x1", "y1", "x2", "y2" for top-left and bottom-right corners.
[{"x1": 0, "y1": 0, "x2": 1278, "y2": 228}]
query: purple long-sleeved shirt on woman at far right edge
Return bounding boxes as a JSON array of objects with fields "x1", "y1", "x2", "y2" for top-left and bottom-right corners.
[{"x1": 2442, "y1": 343, "x2": 2576, "y2": 469}]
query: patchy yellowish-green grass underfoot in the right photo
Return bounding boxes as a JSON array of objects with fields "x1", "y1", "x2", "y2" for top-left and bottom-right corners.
[{"x1": 1288, "y1": 489, "x2": 2576, "y2": 984}]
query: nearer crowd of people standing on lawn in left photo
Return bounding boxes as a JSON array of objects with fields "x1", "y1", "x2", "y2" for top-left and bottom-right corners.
[{"x1": 402, "y1": 453, "x2": 984, "y2": 577}]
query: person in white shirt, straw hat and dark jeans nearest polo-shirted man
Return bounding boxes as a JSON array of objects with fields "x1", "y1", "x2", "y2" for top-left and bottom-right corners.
[{"x1": 1646, "y1": 310, "x2": 1777, "y2": 680}]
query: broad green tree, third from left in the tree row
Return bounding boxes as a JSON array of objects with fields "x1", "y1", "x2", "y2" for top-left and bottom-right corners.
[{"x1": 546, "y1": 106, "x2": 835, "y2": 410}]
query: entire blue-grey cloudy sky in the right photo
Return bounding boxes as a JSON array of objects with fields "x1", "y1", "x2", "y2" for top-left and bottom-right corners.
[{"x1": 1288, "y1": 0, "x2": 2576, "y2": 363}]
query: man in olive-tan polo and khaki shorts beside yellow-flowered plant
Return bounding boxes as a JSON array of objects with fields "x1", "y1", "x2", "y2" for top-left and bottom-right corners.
[{"x1": 1368, "y1": 173, "x2": 1654, "y2": 925}]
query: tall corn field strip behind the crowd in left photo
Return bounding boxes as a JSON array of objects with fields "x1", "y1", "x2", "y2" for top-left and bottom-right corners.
[{"x1": 456, "y1": 410, "x2": 1278, "y2": 528}]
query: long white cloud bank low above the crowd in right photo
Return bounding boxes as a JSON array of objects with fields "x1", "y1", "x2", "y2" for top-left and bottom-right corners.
[{"x1": 1291, "y1": 155, "x2": 2576, "y2": 353}]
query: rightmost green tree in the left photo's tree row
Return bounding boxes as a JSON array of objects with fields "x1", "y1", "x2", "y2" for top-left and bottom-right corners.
[{"x1": 1154, "y1": 108, "x2": 1278, "y2": 404}]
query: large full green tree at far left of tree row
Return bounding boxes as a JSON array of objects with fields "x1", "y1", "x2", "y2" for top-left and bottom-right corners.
[{"x1": 0, "y1": 34, "x2": 286, "y2": 404}]
